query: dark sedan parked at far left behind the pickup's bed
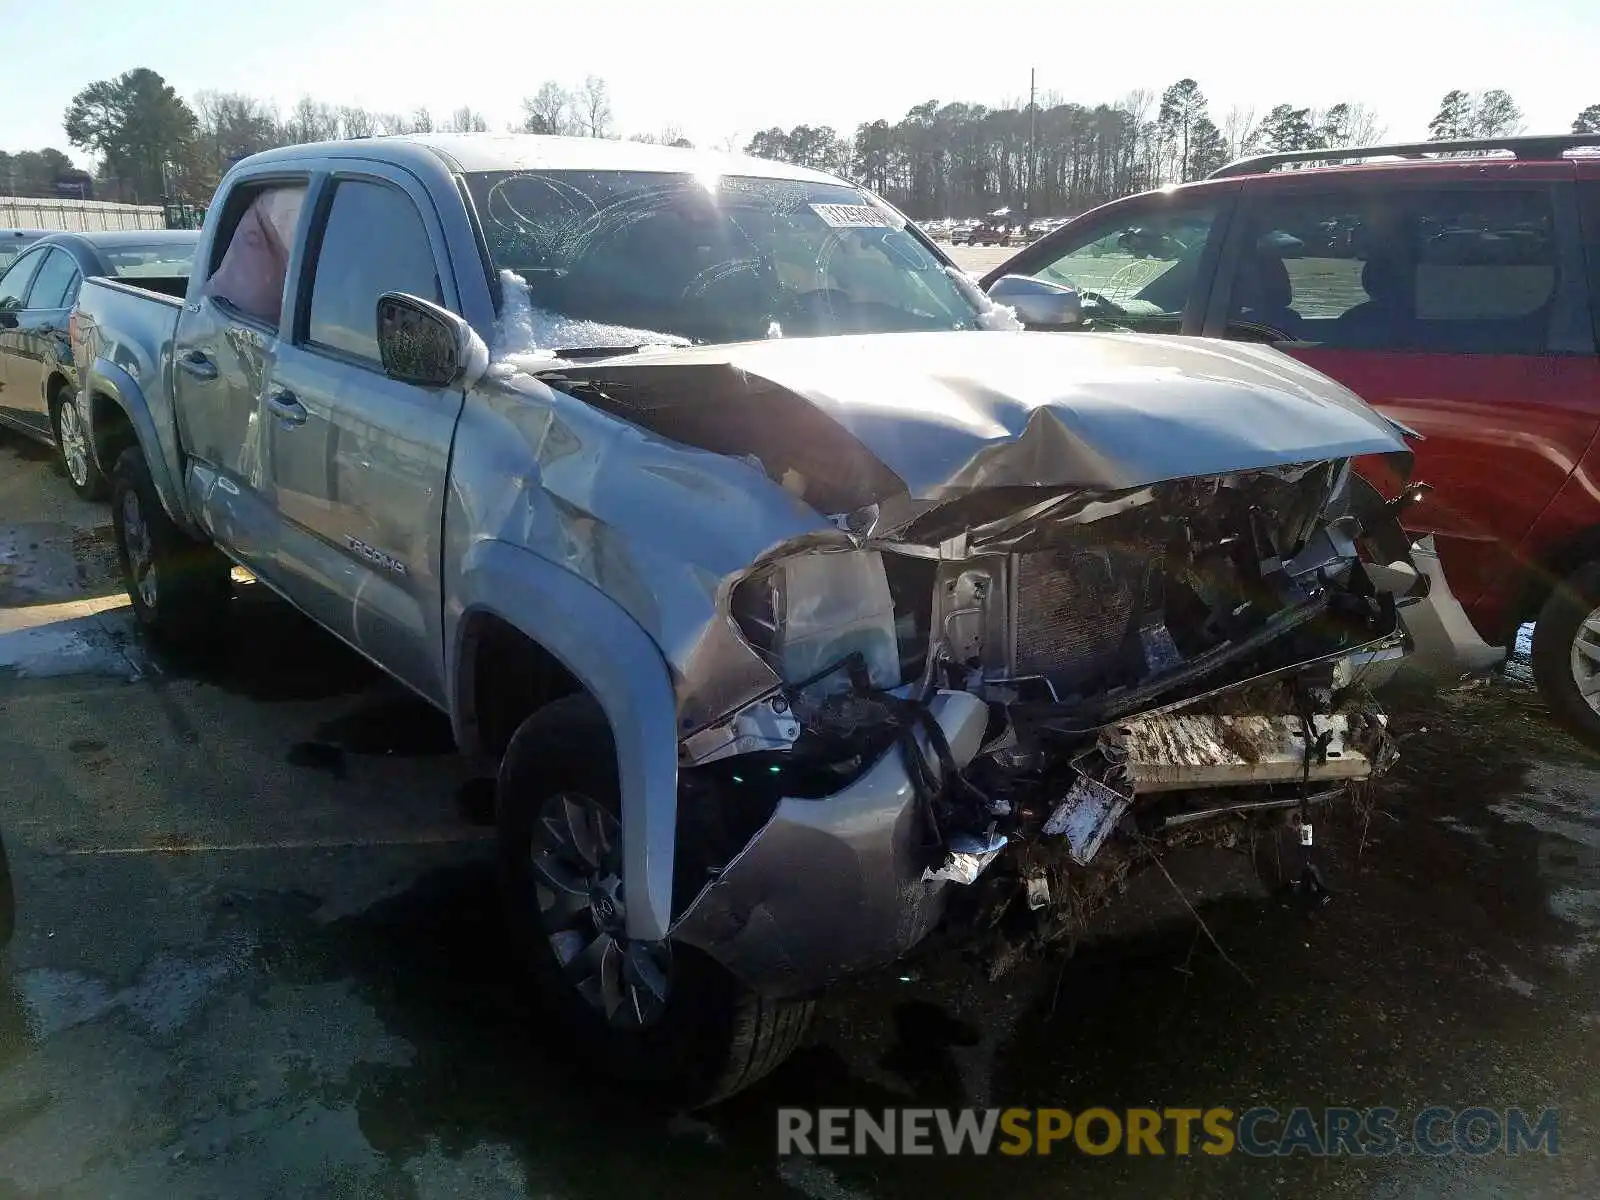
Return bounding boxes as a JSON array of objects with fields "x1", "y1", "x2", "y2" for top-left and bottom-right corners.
[{"x1": 0, "y1": 229, "x2": 200, "y2": 499}]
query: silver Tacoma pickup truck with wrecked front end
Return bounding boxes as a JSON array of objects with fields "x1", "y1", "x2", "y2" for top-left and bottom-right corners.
[{"x1": 74, "y1": 136, "x2": 1419, "y2": 1099}]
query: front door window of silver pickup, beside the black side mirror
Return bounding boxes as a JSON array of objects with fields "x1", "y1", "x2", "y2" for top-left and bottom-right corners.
[{"x1": 306, "y1": 179, "x2": 443, "y2": 363}]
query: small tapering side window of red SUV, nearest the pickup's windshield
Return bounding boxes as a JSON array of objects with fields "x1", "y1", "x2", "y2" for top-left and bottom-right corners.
[{"x1": 1034, "y1": 205, "x2": 1216, "y2": 317}]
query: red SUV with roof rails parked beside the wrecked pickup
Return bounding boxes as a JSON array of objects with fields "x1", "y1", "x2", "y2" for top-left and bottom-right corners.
[{"x1": 984, "y1": 134, "x2": 1600, "y2": 746}]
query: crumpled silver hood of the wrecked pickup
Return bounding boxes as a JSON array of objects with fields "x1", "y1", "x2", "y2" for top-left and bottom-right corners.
[{"x1": 540, "y1": 331, "x2": 1406, "y2": 501}]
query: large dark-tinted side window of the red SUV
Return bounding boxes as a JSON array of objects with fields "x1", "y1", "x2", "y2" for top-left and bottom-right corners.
[{"x1": 1229, "y1": 189, "x2": 1557, "y2": 354}]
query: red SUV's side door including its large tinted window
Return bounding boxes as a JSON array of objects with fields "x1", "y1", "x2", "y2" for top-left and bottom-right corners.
[{"x1": 1205, "y1": 178, "x2": 1600, "y2": 624}]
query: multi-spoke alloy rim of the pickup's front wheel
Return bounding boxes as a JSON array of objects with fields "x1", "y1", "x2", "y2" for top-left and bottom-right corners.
[{"x1": 531, "y1": 792, "x2": 672, "y2": 1029}]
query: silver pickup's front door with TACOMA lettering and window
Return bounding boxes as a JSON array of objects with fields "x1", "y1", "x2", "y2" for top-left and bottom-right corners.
[{"x1": 264, "y1": 162, "x2": 464, "y2": 702}]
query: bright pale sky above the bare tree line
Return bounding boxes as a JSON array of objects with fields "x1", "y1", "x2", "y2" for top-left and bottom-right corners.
[{"x1": 0, "y1": 0, "x2": 1600, "y2": 165}]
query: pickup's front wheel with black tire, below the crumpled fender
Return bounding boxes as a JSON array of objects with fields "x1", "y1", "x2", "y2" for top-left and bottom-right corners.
[{"x1": 496, "y1": 694, "x2": 814, "y2": 1106}]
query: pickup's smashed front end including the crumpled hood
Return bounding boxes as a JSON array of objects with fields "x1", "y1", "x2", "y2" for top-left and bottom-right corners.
[{"x1": 541, "y1": 333, "x2": 1426, "y2": 994}]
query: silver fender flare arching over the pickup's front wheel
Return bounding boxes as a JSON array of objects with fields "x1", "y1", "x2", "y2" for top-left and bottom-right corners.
[{"x1": 446, "y1": 539, "x2": 678, "y2": 941}]
